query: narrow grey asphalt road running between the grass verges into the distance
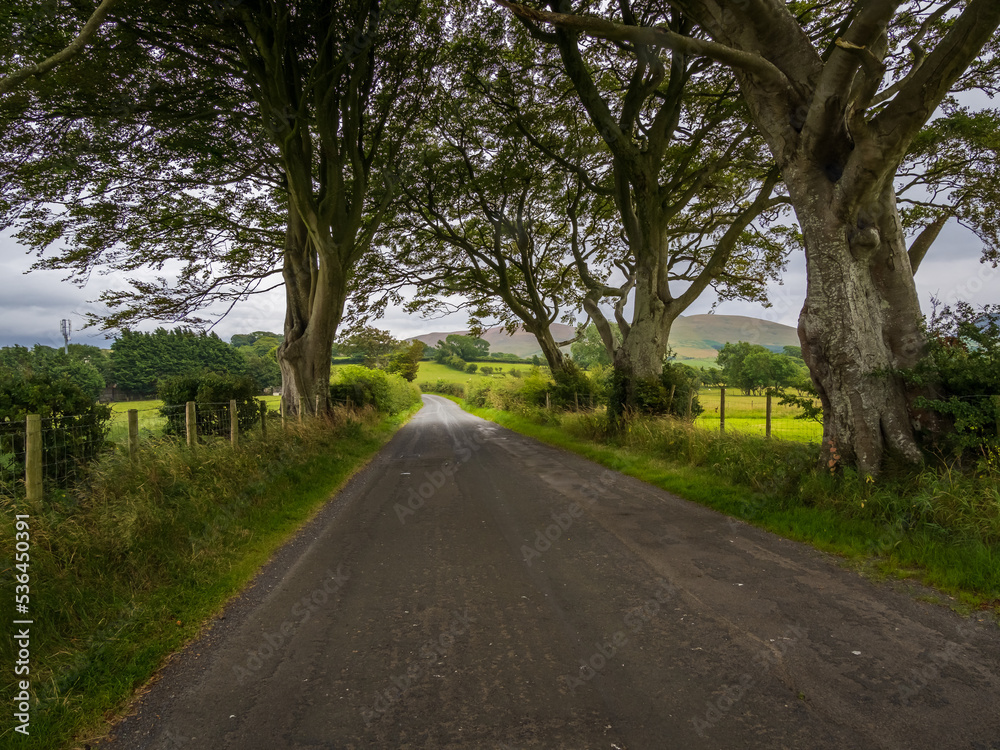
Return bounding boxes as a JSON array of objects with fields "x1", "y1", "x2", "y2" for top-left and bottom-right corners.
[{"x1": 99, "y1": 396, "x2": 1000, "y2": 750}]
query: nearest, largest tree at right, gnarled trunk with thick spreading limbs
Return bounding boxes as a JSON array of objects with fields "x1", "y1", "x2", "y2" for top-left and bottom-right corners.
[{"x1": 499, "y1": 0, "x2": 1000, "y2": 474}]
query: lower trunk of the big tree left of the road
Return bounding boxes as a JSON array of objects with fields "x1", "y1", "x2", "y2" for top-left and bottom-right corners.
[{"x1": 278, "y1": 206, "x2": 347, "y2": 414}]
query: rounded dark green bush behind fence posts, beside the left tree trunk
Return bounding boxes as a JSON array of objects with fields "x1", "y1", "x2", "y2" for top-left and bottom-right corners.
[{"x1": 157, "y1": 373, "x2": 260, "y2": 437}]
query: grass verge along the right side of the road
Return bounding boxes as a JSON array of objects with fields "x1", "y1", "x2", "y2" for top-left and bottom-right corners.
[{"x1": 453, "y1": 399, "x2": 1000, "y2": 620}]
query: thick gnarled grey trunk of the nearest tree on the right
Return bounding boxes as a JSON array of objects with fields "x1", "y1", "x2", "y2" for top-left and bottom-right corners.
[{"x1": 785, "y1": 167, "x2": 924, "y2": 474}]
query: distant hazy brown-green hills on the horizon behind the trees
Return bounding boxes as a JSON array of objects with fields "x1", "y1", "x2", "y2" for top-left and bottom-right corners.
[{"x1": 410, "y1": 315, "x2": 799, "y2": 361}]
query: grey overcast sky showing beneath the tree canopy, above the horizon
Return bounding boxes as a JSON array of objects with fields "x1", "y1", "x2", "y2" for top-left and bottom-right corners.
[{"x1": 0, "y1": 214, "x2": 1000, "y2": 347}]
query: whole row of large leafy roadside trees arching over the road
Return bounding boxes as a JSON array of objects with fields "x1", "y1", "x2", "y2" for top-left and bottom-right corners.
[{"x1": 0, "y1": 0, "x2": 1000, "y2": 473}]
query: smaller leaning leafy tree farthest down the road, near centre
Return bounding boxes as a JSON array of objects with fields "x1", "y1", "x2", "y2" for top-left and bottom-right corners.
[{"x1": 372, "y1": 76, "x2": 607, "y2": 378}]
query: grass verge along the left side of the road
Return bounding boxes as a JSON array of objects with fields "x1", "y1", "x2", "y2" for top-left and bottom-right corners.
[{"x1": 0, "y1": 407, "x2": 417, "y2": 750}]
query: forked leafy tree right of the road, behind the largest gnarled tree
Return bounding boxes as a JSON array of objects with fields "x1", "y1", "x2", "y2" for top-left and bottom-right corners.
[{"x1": 500, "y1": 0, "x2": 786, "y2": 413}]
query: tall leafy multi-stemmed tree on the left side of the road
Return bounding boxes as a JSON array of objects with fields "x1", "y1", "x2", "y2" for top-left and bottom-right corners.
[{"x1": 3, "y1": 0, "x2": 440, "y2": 408}]
